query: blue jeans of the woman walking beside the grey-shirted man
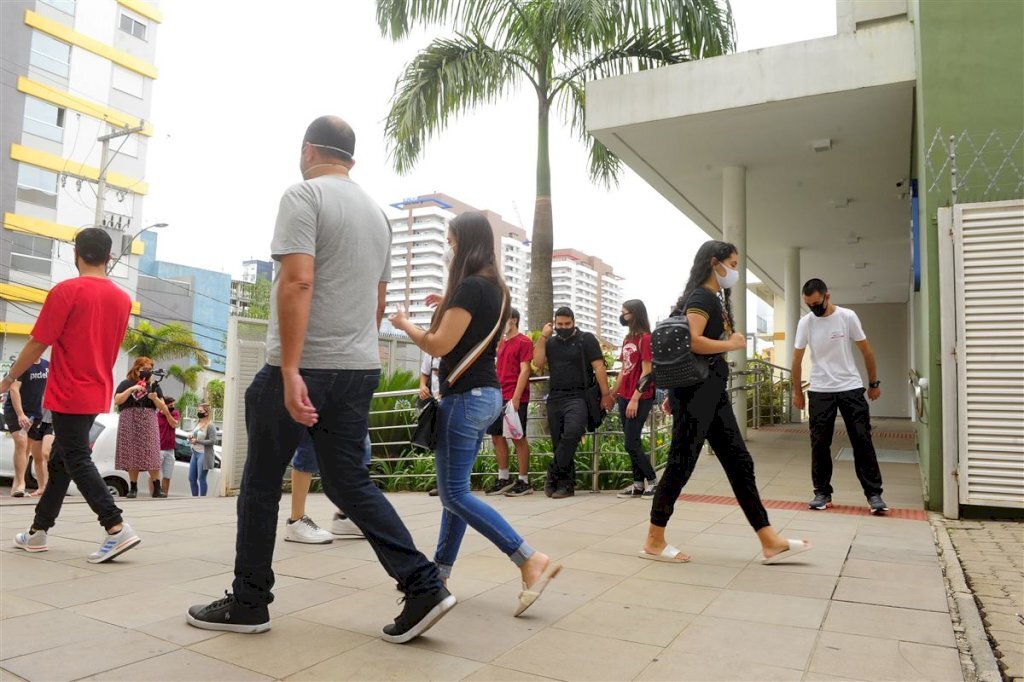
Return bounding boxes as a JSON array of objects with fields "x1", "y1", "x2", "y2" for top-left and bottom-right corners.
[{"x1": 434, "y1": 388, "x2": 534, "y2": 578}]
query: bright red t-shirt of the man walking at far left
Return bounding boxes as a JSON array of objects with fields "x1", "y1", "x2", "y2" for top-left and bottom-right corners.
[{"x1": 32, "y1": 276, "x2": 131, "y2": 415}]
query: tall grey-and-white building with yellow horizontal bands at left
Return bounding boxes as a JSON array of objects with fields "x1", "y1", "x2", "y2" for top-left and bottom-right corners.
[{"x1": 0, "y1": 0, "x2": 162, "y2": 372}]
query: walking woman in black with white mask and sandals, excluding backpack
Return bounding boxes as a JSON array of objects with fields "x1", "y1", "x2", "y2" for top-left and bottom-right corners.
[{"x1": 640, "y1": 242, "x2": 810, "y2": 563}]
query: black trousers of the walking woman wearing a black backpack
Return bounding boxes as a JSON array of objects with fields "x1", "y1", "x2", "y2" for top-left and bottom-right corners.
[{"x1": 650, "y1": 360, "x2": 770, "y2": 530}]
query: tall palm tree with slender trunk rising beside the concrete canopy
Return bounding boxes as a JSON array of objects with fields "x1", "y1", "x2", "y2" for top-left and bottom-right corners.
[{"x1": 377, "y1": 0, "x2": 735, "y2": 326}]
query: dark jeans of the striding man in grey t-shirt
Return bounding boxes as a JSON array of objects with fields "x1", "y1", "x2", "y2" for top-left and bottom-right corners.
[{"x1": 232, "y1": 365, "x2": 441, "y2": 606}]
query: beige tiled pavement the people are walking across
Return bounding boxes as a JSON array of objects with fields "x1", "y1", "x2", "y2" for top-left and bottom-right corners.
[{"x1": 0, "y1": 421, "x2": 963, "y2": 680}]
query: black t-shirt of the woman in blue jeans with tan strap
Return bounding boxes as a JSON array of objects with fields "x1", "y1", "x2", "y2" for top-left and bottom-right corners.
[{"x1": 438, "y1": 275, "x2": 502, "y2": 395}]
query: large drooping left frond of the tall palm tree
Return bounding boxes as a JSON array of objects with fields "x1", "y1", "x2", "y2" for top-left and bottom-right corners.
[{"x1": 384, "y1": 34, "x2": 528, "y2": 173}]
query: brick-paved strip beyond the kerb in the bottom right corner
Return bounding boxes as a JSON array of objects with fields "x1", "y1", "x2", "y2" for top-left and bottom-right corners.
[{"x1": 944, "y1": 520, "x2": 1024, "y2": 680}]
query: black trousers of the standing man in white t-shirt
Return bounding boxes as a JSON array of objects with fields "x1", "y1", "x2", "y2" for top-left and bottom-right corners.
[{"x1": 807, "y1": 388, "x2": 882, "y2": 498}]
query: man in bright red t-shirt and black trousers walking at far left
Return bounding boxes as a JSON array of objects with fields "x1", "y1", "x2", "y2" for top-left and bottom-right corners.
[{"x1": 0, "y1": 227, "x2": 145, "y2": 563}]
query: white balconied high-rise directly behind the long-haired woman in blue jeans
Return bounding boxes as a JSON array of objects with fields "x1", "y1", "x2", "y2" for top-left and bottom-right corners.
[{"x1": 387, "y1": 194, "x2": 529, "y2": 329}]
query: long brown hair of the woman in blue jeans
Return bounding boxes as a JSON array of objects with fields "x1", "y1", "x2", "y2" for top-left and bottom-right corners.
[{"x1": 430, "y1": 211, "x2": 510, "y2": 332}]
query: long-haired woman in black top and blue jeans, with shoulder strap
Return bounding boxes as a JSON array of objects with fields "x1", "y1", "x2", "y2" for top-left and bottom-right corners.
[{"x1": 390, "y1": 212, "x2": 561, "y2": 615}]
